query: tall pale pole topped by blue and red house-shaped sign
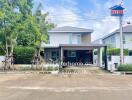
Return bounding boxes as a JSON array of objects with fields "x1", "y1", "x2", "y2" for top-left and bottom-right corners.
[{"x1": 110, "y1": 5, "x2": 124, "y2": 64}]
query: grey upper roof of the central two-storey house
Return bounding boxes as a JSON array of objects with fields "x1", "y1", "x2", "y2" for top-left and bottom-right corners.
[{"x1": 49, "y1": 26, "x2": 93, "y2": 33}]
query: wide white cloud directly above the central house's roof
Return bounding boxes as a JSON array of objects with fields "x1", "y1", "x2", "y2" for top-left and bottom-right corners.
[{"x1": 43, "y1": 6, "x2": 80, "y2": 26}]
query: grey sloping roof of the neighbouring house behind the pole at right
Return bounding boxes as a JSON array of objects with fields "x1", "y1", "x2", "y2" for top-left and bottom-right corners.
[{"x1": 102, "y1": 24, "x2": 132, "y2": 39}]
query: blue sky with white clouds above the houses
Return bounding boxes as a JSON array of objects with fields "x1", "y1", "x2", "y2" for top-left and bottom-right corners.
[{"x1": 34, "y1": 0, "x2": 132, "y2": 41}]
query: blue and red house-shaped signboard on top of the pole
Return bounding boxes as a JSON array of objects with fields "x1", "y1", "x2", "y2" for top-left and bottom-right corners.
[{"x1": 110, "y1": 5, "x2": 124, "y2": 16}]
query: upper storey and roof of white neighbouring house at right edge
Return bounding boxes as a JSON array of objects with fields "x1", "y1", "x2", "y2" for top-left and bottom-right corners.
[{"x1": 102, "y1": 25, "x2": 132, "y2": 55}]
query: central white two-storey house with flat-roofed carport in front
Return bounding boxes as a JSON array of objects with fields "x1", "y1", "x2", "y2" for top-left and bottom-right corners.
[{"x1": 42, "y1": 26, "x2": 107, "y2": 69}]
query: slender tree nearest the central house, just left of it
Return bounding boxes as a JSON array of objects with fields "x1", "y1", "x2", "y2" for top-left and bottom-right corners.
[{"x1": 35, "y1": 3, "x2": 54, "y2": 66}]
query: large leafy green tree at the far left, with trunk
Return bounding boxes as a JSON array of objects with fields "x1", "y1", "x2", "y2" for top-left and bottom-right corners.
[{"x1": 0, "y1": 0, "x2": 38, "y2": 68}]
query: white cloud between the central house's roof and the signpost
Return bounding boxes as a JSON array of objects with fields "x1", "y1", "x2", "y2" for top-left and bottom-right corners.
[{"x1": 92, "y1": 16, "x2": 119, "y2": 40}]
